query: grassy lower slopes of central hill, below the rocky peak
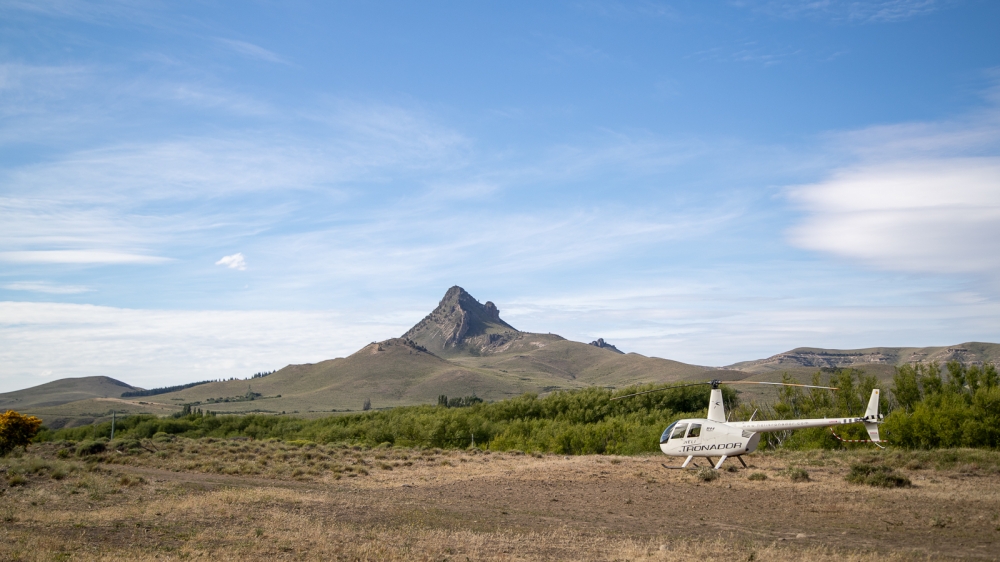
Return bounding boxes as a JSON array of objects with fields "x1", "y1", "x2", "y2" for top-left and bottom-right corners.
[{"x1": 137, "y1": 333, "x2": 728, "y2": 414}]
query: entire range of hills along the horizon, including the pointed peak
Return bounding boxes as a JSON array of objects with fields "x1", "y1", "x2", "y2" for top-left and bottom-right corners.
[{"x1": 7, "y1": 286, "x2": 1000, "y2": 426}]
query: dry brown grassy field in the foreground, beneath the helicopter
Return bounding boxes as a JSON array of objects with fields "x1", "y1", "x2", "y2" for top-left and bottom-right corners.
[{"x1": 0, "y1": 437, "x2": 1000, "y2": 561}]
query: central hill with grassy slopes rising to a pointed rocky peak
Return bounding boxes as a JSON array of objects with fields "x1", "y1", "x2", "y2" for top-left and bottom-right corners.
[{"x1": 133, "y1": 287, "x2": 724, "y2": 414}]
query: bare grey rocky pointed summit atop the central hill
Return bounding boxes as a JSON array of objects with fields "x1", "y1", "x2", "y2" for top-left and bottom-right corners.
[{"x1": 403, "y1": 285, "x2": 521, "y2": 355}]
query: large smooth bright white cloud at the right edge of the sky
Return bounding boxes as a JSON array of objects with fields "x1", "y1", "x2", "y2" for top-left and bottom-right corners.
[{"x1": 790, "y1": 157, "x2": 1000, "y2": 278}]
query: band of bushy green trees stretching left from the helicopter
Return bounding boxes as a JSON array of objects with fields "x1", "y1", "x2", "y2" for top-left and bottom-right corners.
[{"x1": 40, "y1": 385, "x2": 737, "y2": 454}]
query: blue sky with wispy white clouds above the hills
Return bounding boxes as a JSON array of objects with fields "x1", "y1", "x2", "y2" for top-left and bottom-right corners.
[{"x1": 0, "y1": 0, "x2": 1000, "y2": 391}]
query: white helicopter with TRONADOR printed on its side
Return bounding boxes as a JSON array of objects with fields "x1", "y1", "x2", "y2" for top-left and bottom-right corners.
[{"x1": 612, "y1": 380, "x2": 883, "y2": 470}]
